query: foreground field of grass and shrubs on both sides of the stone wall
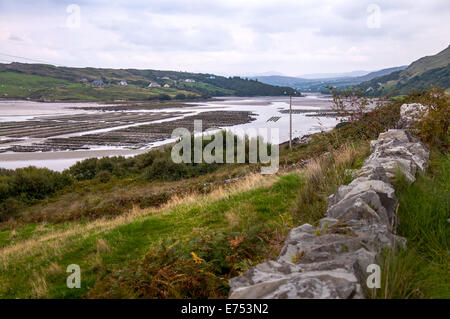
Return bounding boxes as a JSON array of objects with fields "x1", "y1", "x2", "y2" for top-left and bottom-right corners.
[{"x1": 0, "y1": 92, "x2": 450, "y2": 298}]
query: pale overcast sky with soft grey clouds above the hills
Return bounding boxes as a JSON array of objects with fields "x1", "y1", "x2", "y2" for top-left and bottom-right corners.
[{"x1": 0, "y1": 0, "x2": 450, "y2": 76}]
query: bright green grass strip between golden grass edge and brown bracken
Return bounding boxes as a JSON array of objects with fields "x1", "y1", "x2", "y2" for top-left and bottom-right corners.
[{"x1": 0, "y1": 174, "x2": 300, "y2": 297}]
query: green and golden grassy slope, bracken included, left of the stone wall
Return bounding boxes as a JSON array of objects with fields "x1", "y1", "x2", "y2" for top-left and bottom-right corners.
[{"x1": 0, "y1": 139, "x2": 366, "y2": 298}]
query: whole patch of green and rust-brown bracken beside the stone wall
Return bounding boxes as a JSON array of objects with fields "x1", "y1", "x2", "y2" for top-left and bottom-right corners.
[{"x1": 87, "y1": 223, "x2": 282, "y2": 299}]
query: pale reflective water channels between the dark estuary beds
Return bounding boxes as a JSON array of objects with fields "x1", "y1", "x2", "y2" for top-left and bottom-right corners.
[{"x1": 0, "y1": 94, "x2": 339, "y2": 171}]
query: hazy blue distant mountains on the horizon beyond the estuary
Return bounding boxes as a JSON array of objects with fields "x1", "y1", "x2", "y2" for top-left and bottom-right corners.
[{"x1": 253, "y1": 66, "x2": 406, "y2": 93}]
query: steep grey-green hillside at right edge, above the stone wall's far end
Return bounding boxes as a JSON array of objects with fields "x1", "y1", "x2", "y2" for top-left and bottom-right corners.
[{"x1": 358, "y1": 46, "x2": 450, "y2": 95}]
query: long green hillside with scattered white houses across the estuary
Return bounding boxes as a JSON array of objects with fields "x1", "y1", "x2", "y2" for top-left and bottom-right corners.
[{"x1": 0, "y1": 63, "x2": 294, "y2": 101}]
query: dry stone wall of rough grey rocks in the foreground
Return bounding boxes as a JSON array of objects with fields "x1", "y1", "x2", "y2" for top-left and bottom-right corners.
[{"x1": 230, "y1": 104, "x2": 429, "y2": 299}]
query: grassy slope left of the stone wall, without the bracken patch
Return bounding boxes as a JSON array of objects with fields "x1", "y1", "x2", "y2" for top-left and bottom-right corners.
[{"x1": 0, "y1": 135, "x2": 367, "y2": 298}]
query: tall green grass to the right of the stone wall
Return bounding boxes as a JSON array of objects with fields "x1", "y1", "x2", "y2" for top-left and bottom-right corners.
[{"x1": 376, "y1": 150, "x2": 450, "y2": 299}]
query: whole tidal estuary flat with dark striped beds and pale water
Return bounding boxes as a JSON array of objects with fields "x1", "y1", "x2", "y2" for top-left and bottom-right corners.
[{"x1": 0, "y1": 95, "x2": 337, "y2": 170}]
